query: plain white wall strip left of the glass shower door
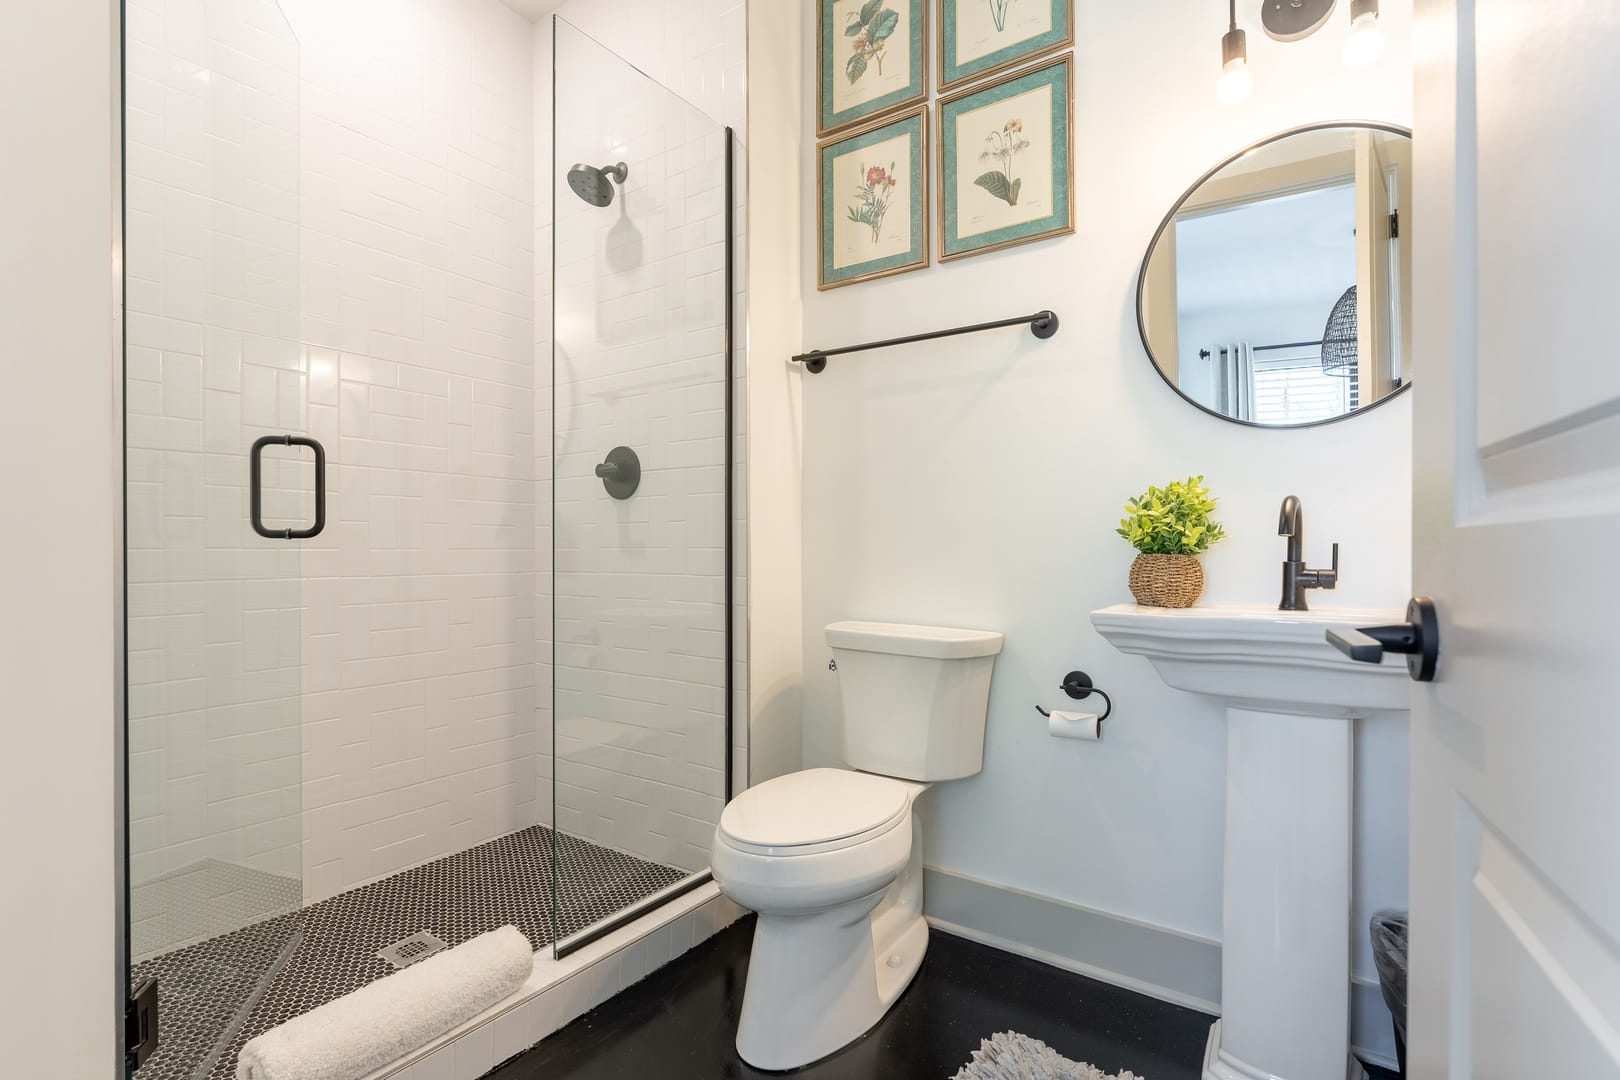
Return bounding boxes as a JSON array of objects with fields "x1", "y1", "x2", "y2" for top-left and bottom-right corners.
[{"x1": 0, "y1": 3, "x2": 123, "y2": 1080}]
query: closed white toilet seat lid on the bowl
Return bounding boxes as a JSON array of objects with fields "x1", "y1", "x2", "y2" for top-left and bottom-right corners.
[{"x1": 718, "y1": 769, "x2": 912, "y2": 858}]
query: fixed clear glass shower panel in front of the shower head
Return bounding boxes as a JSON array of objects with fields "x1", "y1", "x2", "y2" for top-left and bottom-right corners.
[{"x1": 552, "y1": 19, "x2": 731, "y2": 950}]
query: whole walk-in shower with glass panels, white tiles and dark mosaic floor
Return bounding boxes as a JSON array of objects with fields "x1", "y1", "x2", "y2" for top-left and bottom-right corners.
[{"x1": 125, "y1": 0, "x2": 740, "y2": 1080}]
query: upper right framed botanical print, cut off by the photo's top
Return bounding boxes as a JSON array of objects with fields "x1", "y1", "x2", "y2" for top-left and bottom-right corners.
[{"x1": 940, "y1": 0, "x2": 1074, "y2": 91}]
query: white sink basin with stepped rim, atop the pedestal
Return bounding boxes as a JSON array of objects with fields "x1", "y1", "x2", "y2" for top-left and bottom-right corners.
[{"x1": 1092, "y1": 604, "x2": 1411, "y2": 717}]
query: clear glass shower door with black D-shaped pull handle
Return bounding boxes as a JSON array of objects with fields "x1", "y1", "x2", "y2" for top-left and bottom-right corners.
[{"x1": 125, "y1": 0, "x2": 304, "y2": 1080}]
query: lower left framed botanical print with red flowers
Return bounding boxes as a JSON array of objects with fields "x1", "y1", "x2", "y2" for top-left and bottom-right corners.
[{"x1": 816, "y1": 105, "x2": 928, "y2": 288}]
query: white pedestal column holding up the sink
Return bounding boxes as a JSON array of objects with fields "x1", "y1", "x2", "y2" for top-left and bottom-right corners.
[{"x1": 1204, "y1": 708, "x2": 1354, "y2": 1080}]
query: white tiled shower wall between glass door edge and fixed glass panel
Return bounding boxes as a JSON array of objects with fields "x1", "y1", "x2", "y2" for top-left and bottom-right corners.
[{"x1": 287, "y1": 0, "x2": 548, "y2": 900}]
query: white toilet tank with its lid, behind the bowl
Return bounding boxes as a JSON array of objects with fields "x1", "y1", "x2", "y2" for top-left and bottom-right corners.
[{"x1": 826, "y1": 622, "x2": 1001, "y2": 782}]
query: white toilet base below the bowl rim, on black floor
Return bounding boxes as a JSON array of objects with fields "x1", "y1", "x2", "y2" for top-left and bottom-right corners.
[{"x1": 737, "y1": 816, "x2": 928, "y2": 1072}]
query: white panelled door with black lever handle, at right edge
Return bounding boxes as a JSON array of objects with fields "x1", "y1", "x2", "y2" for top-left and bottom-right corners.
[{"x1": 1408, "y1": 0, "x2": 1620, "y2": 1080}]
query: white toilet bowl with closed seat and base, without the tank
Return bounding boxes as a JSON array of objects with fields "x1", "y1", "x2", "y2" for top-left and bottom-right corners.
[{"x1": 711, "y1": 769, "x2": 928, "y2": 1070}]
